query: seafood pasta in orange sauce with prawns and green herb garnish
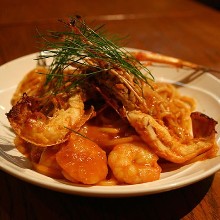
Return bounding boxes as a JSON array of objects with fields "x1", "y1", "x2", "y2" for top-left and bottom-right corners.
[{"x1": 6, "y1": 16, "x2": 218, "y2": 186}]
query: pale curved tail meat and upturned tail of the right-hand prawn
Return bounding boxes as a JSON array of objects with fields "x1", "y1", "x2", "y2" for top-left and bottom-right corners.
[{"x1": 127, "y1": 110, "x2": 216, "y2": 163}]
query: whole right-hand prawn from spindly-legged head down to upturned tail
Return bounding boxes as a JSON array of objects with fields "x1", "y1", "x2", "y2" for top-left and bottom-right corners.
[{"x1": 91, "y1": 62, "x2": 217, "y2": 163}]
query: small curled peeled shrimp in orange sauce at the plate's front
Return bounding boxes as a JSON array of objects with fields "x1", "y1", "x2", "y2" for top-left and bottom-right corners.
[{"x1": 108, "y1": 141, "x2": 161, "y2": 184}]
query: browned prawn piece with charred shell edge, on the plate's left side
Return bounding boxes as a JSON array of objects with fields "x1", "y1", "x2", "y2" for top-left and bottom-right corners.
[{"x1": 6, "y1": 92, "x2": 92, "y2": 147}]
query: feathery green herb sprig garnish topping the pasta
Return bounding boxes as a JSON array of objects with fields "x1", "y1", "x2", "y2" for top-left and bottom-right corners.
[{"x1": 38, "y1": 16, "x2": 153, "y2": 90}]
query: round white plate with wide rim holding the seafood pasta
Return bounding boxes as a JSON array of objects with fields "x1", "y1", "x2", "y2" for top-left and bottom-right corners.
[{"x1": 0, "y1": 54, "x2": 220, "y2": 197}]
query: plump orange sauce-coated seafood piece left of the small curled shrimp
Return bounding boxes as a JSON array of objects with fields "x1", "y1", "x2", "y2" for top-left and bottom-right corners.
[{"x1": 56, "y1": 133, "x2": 108, "y2": 184}]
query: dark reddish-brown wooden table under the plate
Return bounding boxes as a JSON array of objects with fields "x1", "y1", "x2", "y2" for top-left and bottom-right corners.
[{"x1": 0, "y1": 0, "x2": 220, "y2": 220}]
